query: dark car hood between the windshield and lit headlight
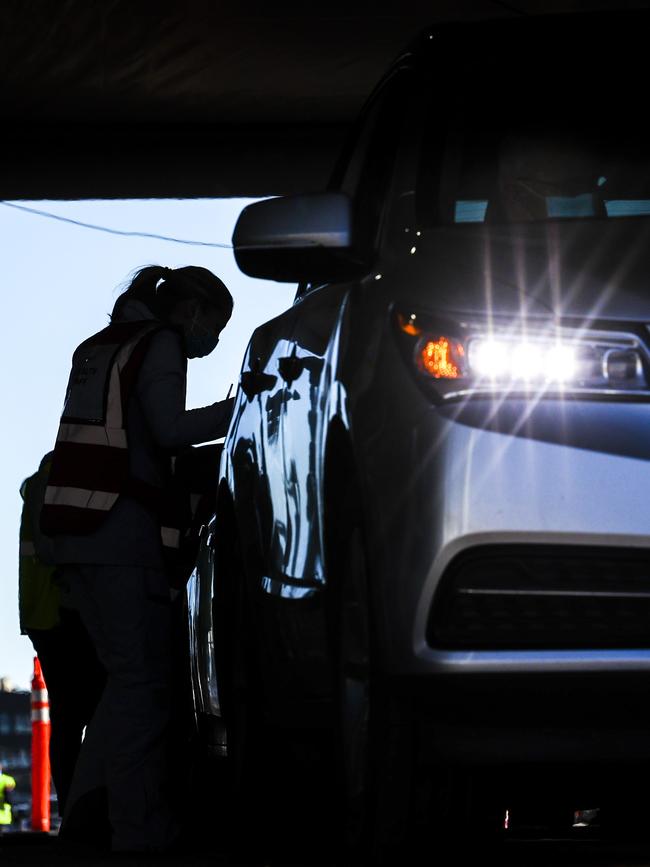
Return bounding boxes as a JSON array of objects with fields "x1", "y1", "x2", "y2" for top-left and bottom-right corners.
[{"x1": 399, "y1": 220, "x2": 650, "y2": 322}]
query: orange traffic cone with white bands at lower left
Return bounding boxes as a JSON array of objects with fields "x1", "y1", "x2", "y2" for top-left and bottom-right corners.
[{"x1": 32, "y1": 656, "x2": 50, "y2": 831}]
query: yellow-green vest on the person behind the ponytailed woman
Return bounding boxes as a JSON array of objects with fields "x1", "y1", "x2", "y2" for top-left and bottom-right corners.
[{"x1": 18, "y1": 458, "x2": 61, "y2": 635}]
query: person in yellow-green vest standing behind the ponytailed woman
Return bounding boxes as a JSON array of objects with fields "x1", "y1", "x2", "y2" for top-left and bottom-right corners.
[{"x1": 18, "y1": 452, "x2": 106, "y2": 816}]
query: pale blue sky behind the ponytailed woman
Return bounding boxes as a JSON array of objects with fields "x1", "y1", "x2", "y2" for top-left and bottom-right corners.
[{"x1": 0, "y1": 199, "x2": 295, "y2": 689}]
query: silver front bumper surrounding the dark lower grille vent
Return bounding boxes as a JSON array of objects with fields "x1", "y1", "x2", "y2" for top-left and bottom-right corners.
[{"x1": 374, "y1": 400, "x2": 650, "y2": 677}]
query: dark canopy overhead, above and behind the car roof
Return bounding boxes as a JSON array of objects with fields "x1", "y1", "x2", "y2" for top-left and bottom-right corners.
[{"x1": 0, "y1": 0, "x2": 648, "y2": 199}]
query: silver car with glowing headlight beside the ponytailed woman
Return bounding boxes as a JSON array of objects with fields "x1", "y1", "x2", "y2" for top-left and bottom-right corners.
[{"x1": 185, "y1": 13, "x2": 650, "y2": 860}]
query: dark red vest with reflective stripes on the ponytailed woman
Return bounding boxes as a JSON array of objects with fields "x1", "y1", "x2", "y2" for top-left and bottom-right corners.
[{"x1": 41, "y1": 320, "x2": 180, "y2": 550}]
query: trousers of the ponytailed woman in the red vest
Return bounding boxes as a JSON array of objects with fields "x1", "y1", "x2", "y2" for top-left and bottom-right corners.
[{"x1": 63, "y1": 565, "x2": 178, "y2": 851}]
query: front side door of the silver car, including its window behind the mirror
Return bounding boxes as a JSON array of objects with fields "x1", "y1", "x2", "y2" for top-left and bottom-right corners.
[{"x1": 279, "y1": 68, "x2": 411, "y2": 599}]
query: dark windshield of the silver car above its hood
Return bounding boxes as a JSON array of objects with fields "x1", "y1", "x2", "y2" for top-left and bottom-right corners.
[{"x1": 420, "y1": 37, "x2": 650, "y2": 224}]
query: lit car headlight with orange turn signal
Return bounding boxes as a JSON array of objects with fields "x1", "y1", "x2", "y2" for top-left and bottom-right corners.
[{"x1": 395, "y1": 311, "x2": 650, "y2": 399}]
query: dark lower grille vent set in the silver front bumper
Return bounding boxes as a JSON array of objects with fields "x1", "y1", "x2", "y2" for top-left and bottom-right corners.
[{"x1": 427, "y1": 545, "x2": 650, "y2": 649}]
